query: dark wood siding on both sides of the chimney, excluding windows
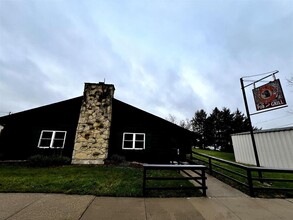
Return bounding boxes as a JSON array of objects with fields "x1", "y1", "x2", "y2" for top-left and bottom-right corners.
[{"x1": 0, "y1": 97, "x2": 196, "y2": 163}]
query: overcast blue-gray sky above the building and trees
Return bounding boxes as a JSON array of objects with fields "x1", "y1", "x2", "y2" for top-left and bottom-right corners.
[{"x1": 0, "y1": 0, "x2": 293, "y2": 128}]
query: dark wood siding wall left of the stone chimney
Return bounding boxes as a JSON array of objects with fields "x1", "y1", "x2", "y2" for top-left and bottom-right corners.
[{"x1": 0, "y1": 97, "x2": 82, "y2": 160}]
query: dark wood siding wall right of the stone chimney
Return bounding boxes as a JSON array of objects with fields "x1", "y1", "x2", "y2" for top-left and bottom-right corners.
[{"x1": 109, "y1": 99, "x2": 195, "y2": 163}]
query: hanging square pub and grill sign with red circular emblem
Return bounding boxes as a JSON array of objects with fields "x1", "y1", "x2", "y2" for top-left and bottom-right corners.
[{"x1": 252, "y1": 79, "x2": 286, "y2": 111}]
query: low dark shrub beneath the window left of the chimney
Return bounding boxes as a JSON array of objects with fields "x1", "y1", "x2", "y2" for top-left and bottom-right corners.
[{"x1": 28, "y1": 155, "x2": 71, "y2": 167}]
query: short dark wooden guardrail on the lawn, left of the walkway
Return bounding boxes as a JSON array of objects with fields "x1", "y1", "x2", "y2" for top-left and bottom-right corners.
[{"x1": 143, "y1": 164, "x2": 207, "y2": 196}]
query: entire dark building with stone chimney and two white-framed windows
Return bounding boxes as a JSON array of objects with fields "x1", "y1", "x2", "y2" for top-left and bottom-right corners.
[{"x1": 0, "y1": 83, "x2": 196, "y2": 164}]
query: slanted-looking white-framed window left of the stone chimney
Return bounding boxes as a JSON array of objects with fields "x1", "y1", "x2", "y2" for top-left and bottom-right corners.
[{"x1": 38, "y1": 130, "x2": 66, "y2": 148}]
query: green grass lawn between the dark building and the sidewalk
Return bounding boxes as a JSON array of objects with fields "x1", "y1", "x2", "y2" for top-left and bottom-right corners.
[{"x1": 0, "y1": 165, "x2": 201, "y2": 197}]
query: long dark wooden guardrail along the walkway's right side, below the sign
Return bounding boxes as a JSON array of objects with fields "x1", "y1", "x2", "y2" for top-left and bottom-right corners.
[{"x1": 189, "y1": 152, "x2": 293, "y2": 197}]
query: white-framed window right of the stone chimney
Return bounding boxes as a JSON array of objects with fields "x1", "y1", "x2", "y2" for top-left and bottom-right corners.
[{"x1": 122, "y1": 133, "x2": 145, "y2": 150}]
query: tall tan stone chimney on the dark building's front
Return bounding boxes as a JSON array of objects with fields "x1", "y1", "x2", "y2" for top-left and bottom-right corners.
[{"x1": 72, "y1": 82, "x2": 115, "y2": 164}]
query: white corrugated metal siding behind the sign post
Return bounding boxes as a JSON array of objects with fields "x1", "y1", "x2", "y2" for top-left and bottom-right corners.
[{"x1": 232, "y1": 128, "x2": 293, "y2": 169}]
